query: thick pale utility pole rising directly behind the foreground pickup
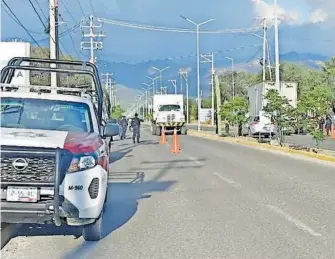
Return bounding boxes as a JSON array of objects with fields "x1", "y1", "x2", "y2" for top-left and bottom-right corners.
[{"x1": 49, "y1": 0, "x2": 58, "y2": 93}]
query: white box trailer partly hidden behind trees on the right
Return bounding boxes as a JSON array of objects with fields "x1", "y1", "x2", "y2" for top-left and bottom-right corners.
[{"x1": 248, "y1": 82, "x2": 298, "y2": 116}]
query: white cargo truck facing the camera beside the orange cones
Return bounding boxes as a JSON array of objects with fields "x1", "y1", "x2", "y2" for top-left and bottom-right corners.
[{"x1": 151, "y1": 94, "x2": 186, "y2": 136}]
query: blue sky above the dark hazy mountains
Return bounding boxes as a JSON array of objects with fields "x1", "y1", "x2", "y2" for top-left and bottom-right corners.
[{"x1": 1, "y1": 0, "x2": 335, "y2": 65}]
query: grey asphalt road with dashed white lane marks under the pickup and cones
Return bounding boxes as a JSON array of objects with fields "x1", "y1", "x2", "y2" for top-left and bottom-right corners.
[{"x1": 2, "y1": 128, "x2": 335, "y2": 259}]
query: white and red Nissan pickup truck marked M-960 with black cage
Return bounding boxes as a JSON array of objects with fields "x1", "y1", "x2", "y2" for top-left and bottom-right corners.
[{"x1": 0, "y1": 59, "x2": 119, "y2": 241}]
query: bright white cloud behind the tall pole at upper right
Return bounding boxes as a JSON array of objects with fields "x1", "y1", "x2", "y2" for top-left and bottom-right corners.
[{"x1": 251, "y1": 0, "x2": 301, "y2": 25}]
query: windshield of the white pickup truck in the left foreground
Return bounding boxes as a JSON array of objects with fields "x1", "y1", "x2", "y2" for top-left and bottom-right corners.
[{"x1": 0, "y1": 97, "x2": 93, "y2": 132}]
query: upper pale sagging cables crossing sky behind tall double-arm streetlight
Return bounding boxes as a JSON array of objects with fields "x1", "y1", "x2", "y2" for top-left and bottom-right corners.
[{"x1": 97, "y1": 18, "x2": 260, "y2": 34}]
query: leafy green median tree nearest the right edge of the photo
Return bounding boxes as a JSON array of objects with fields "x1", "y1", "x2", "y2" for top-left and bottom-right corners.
[{"x1": 299, "y1": 85, "x2": 333, "y2": 147}]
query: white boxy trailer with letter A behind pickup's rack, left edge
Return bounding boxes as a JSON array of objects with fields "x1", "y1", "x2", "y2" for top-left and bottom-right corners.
[{"x1": 0, "y1": 42, "x2": 31, "y2": 85}]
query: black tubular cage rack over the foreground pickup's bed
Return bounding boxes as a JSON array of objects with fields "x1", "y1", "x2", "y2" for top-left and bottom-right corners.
[{"x1": 0, "y1": 64, "x2": 103, "y2": 121}]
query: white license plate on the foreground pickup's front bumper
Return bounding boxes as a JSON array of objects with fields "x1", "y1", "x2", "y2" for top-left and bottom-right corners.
[{"x1": 7, "y1": 186, "x2": 38, "y2": 202}]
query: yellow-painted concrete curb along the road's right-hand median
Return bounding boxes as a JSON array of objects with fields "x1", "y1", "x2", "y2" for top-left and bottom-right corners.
[{"x1": 187, "y1": 129, "x2": 335, "y2": 163}]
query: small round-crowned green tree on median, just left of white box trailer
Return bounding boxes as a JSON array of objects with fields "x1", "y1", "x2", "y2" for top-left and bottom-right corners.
[{"x1": 221, "y1": 96, "x2": 248, "y2": 136}]
